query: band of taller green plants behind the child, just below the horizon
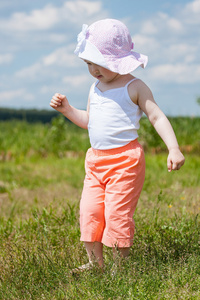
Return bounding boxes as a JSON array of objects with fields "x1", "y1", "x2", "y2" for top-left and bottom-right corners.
[{"x1": 0, "y1": 116, "x2": 200, "y2": 162}]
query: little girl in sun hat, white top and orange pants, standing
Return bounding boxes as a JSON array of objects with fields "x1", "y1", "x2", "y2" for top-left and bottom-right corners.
[{"x1": 50, "y1": 19, "x2": 184, "y2": 270}]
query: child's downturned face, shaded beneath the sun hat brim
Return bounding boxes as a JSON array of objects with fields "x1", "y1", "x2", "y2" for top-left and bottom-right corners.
[{"x1": 84, "y1": 60, "x2": 120, "y2": 83}]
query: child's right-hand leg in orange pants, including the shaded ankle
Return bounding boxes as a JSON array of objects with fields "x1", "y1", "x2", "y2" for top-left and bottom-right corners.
[{"x1": 102, "y1": 141, "x2": 145, "y2": 250}]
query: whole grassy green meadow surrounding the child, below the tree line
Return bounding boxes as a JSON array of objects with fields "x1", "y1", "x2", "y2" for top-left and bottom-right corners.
[{"x1": 0, "y1": 116, "x2": 200, "y2": 300}]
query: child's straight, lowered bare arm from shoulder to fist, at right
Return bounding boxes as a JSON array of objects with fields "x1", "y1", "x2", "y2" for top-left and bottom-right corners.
[{"x1": 137, "y1": 81, "x2": 185, "y2": 172}]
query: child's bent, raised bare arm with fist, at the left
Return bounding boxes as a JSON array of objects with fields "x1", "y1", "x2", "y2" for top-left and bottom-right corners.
[{"x1": 50, "y1": 93, "x2": 89, "y2": 129}]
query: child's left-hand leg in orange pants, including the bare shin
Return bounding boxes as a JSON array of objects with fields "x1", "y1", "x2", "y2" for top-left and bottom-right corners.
[{"x1": 80, "y1": 149, "x2": 105, "y2": 267}]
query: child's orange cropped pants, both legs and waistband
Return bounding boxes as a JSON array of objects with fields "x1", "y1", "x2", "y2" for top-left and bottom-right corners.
[{"x1": 80, "y1": 139, "x2": 145, "y2": 248}]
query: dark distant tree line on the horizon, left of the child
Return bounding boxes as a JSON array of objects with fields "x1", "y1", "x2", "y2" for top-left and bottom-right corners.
[{"x1": 0, "y1": 108, "x2": 59, "y2": 123}]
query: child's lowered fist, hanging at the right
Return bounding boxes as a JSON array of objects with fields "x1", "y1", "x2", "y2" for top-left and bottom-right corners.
[{"x1": 167, "y1": 148, "x2": 185, "y2": 172}]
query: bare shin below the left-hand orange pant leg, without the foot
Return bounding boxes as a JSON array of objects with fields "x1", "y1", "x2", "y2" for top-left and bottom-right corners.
[{"x1": 84, "y1": 242, "x2": 103, "y2": 267}]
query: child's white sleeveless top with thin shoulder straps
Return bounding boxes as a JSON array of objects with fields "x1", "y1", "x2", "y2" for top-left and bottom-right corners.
[{"x1": 88, "y1": 78, "x2": 142, "y2": 150}]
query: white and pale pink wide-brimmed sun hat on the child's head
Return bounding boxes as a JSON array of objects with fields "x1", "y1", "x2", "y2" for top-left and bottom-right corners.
[{"x1": 74, "y1": 19, "x2": 148, "y2": 75}]
